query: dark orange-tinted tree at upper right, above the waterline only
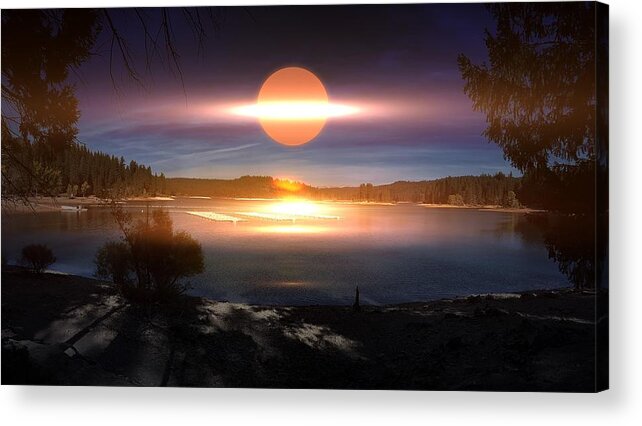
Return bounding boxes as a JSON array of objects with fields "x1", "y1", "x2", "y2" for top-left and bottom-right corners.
[{"x1": 458, "y1": 2, "x2": 596, "y2": 212}]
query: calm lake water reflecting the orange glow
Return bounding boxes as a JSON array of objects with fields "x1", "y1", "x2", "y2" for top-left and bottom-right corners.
[{"x1": 2, "y1": 199, "x2": 568, "y2": 304}]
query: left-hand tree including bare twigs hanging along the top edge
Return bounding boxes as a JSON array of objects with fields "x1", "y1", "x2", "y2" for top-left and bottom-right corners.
[{"x1": 1, "y1": 8, "x2": 219, "y2": 204}]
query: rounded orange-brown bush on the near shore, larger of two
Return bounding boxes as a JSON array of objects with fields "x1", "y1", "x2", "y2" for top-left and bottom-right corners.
[{"x1": 95, "y1": 206, "x2": 204, "y2": 301}]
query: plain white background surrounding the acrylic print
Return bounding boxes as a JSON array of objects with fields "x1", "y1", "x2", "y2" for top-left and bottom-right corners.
[{"x1": 0, "y1": 0, "x2": 642, "y2": 426}]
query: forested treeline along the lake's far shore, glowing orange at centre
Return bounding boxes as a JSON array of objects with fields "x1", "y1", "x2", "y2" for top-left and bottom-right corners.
[{"x1": 3, "y1": 133, "x2": 521, "y2": 208}]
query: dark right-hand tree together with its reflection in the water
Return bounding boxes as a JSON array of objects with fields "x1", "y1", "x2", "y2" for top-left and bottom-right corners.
[{"x1": 459, "y1": 2, "x2": 608, "y2": 289}]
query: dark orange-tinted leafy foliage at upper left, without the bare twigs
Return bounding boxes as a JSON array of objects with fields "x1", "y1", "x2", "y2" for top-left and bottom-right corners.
[{"x1": 2, "y1": 9, "x2": 98, "y2": 150}]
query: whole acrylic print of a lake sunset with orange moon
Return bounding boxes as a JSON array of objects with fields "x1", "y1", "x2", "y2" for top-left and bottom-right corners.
[{"x1": 1, "y1": 2, "x2": 608, "y2": 392}]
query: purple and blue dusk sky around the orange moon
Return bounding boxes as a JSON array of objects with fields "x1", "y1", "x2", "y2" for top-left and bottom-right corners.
[{"x1": 74, "y1": 4, "x2": 517, "y2": 186}]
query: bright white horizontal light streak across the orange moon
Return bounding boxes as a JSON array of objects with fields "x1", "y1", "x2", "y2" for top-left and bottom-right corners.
[{"x1": 231, "y1": 101, "x2": 359, "y2": 121}]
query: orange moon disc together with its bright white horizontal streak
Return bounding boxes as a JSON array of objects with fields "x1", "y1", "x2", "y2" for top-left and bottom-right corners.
[{"x1": 232, "y1": 67, "x2": 358, "y2": 146}]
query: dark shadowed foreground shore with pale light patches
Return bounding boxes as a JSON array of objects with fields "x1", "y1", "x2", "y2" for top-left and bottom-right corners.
[{"x1": 2, "y1": 268, "x2": 608, "y2": 392}]
